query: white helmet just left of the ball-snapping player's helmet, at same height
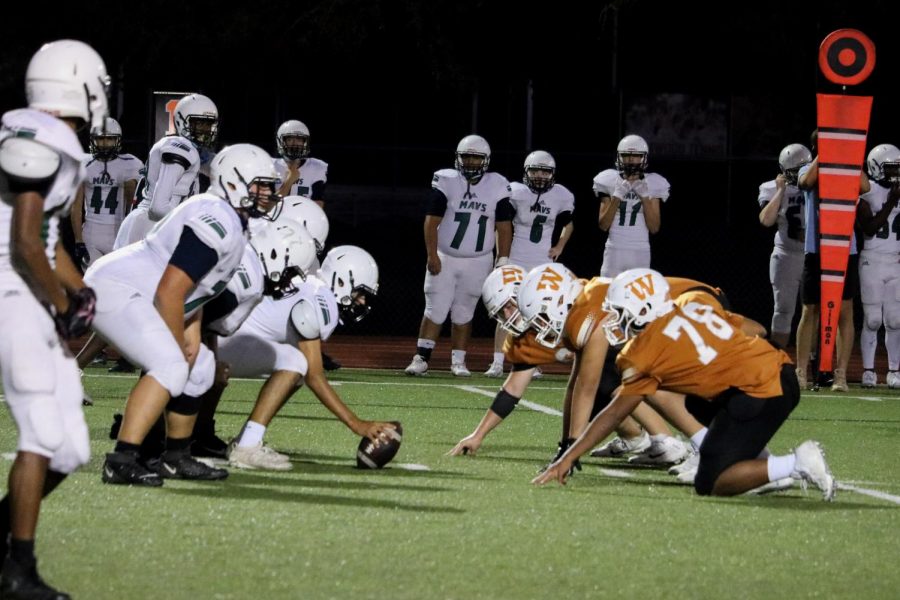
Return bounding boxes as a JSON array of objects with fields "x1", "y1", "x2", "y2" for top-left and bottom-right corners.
[{"x1": 250, "y1": 218, "x2": 316, "y2": 300}]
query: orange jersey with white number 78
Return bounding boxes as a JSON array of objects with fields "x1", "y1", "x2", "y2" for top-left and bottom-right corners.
[{"x1": 616, "y1": 292, "x2": 791, "y2": 399}]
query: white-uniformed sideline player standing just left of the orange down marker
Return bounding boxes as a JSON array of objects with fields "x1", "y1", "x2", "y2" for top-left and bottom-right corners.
[{"x1": 758, "y1": 144, "x2": 812, "y2": 348}]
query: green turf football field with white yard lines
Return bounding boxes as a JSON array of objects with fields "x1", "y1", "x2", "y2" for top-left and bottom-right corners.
[{"x1": 0, "y1": 369, "x2": 900, "y2": 599}]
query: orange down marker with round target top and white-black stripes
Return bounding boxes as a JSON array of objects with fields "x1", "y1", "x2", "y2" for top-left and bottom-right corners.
[{"x1": 816, "y1": 29, "x2": 875, "y2": 371}]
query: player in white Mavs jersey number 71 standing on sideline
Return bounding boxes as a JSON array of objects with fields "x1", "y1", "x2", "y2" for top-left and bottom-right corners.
[{"x1": 406, "y1": 135, "x2": 513, "y2": 377}]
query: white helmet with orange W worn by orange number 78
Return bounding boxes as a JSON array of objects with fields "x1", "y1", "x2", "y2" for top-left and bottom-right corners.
[{"x1": 603, "y1": 269, "x2": 675, "y2": 346}]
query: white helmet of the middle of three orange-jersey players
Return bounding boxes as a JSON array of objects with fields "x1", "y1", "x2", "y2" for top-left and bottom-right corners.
[{"x1": 516, "y1": 263, "x2": 584, "y2": 348}]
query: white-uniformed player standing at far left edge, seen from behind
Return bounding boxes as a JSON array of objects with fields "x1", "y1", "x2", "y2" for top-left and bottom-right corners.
[{"x1": 0, "y1": 40, "x2": 109, "y2": 598}]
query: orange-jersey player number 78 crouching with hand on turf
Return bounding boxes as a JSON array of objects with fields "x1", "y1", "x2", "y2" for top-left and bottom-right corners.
[{"x1": 533, "y1": 269, "x2": 835, "y2": 500}]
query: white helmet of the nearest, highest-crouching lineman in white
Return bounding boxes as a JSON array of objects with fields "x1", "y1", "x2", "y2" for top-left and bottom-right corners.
[{"x1": 208, "y1": 144, "x2": 281, "y2": 220}]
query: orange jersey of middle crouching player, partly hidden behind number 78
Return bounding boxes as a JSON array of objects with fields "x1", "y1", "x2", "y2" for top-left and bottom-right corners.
[{"x1": 563, "y1": 277, "x2": 721, "y2": 352}]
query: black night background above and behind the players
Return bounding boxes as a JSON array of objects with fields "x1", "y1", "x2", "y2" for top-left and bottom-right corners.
[{"x1": 0, "y1": 0, "x2": 900, "y2": 335}]
